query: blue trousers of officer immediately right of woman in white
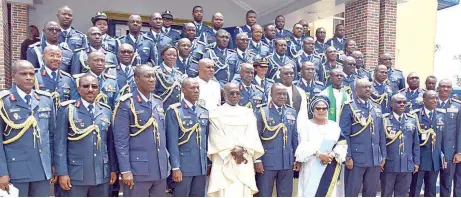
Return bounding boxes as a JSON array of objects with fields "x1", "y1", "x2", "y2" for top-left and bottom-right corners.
[{"x1": 344, "y1": 166, "x2": 381, "y2": 197}]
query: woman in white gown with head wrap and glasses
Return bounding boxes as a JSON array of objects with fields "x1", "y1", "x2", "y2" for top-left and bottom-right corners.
[{"x1": 295, "y1": 96, "x2": 347, "y2": 197}]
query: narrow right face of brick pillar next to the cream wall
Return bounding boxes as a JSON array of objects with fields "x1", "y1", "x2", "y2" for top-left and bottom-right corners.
[{"x1": 379, "y1": 0, "x2": 397, "y2": 57}]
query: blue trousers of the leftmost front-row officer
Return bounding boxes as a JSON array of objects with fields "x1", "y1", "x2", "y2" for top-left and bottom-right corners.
[{"x1": 10, "y1": 180, "x2": 50, "y2": 197}]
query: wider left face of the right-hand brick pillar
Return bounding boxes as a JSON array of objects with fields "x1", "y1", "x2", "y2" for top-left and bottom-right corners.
[{"x1": 345, "y1": 0, "x2": 380, "y2": 68}]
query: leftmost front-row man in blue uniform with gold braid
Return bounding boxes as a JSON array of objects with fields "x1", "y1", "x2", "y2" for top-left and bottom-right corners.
[{"x1": 0, "y1": 60, "x2": 56, "y2": 197}]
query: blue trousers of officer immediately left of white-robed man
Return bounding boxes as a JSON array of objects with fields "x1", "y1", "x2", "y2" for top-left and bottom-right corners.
[{"x1": 173, "y1": 175, "x2": 206, "y2": 197}]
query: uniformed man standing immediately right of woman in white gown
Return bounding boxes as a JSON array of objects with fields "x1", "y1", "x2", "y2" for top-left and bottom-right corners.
[{"x1": 339, "y1": 79, "x2": 387, "y2": 197}]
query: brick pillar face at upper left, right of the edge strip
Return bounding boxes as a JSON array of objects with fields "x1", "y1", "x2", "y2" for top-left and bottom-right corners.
[{"x1": 11, "y1": 3, "x2": 28, "y2": 62}]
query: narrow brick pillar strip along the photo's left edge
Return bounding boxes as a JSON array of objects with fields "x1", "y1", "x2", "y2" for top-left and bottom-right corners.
[{"x1": 0, "y1": 0, "x2": 11, "y2": 90}]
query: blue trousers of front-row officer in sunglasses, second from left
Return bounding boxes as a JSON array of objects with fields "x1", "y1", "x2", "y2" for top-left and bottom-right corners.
[{"x1": 61, "y1": 182, "x2": 109, "y2": 197}]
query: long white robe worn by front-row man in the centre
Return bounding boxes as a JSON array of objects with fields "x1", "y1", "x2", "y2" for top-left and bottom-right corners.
[{"x1": 207, "y1": 103, "x2": 264, "y2": 197}]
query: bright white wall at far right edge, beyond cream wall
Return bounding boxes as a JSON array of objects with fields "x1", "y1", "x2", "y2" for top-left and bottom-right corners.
[{"x1": 434, "y1": 5, "x2": 461, "y2": 88}]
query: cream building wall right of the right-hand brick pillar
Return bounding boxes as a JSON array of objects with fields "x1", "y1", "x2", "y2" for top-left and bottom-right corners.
[{"x1": 395, "y1": 0, "x2": 437, "y2": 85}]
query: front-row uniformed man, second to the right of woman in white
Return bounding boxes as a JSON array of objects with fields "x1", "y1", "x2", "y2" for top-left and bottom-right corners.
[{"x1": 381, "y1": 94, "x2": 420, "y2": 197}]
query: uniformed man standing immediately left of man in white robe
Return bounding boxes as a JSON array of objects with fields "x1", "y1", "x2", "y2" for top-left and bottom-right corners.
[{"x1": 166, "y1": 78, "x2": 208, "y2": 197}]
